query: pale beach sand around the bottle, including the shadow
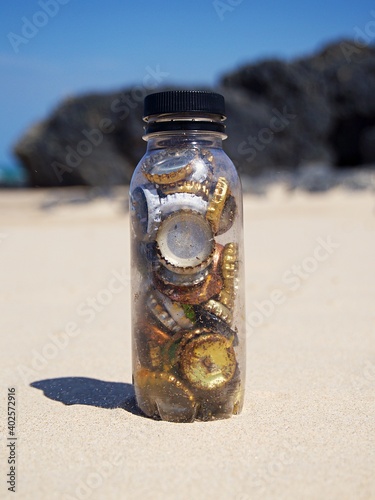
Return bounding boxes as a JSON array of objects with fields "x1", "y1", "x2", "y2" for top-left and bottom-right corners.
[{"x1": 0, "y1": 186, "x2": 375, "y2": 500}]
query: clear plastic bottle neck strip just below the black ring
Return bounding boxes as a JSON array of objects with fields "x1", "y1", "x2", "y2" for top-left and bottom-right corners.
[{"x1": 143, "y1": 130, "x2": 226, "y2": 152}]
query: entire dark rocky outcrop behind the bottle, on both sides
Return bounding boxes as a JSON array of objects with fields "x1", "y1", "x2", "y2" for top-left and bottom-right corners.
[{"x1": 15, "y1": 41, "x2": 375, "y2": 186}]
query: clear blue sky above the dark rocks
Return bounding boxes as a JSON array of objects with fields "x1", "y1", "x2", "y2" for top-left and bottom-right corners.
[{"x1": 0, "y1": 0, "x2": 375, "y2": 168}]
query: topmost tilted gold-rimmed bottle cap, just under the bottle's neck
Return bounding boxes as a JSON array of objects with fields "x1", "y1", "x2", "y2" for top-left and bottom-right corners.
[{"x1": 143, "y1": 150, "x2": 196, "y2": 185}]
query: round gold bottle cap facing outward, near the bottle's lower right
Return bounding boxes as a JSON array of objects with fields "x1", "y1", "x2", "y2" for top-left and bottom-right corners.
[{"x1": 179, "y1": 333, "x2": 237, "y2": 390}]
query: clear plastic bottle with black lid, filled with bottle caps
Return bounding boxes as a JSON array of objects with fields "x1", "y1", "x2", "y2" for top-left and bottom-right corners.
[{"x1": 130, "y1": 91, "x2": 245, "y2": 422}]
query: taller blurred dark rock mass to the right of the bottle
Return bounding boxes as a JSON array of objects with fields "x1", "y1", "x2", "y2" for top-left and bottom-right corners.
[{"x1": 222, "y1": 41, "x2": 375, "y2": 173}]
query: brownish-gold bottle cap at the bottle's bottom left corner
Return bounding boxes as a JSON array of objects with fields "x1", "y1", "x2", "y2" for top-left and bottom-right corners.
[{"x1": 134, "y1": 368, "x2": 197, "y2": 422}]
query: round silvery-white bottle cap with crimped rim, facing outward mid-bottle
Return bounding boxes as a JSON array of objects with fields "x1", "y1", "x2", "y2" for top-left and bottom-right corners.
[{"x1": 156, "y1": 209, "x2": 215, "y2": 274}]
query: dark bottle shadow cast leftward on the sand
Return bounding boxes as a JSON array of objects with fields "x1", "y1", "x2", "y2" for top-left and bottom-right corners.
[{"x1": 30, "y1": 377, "x2": 145, "y2": 417}]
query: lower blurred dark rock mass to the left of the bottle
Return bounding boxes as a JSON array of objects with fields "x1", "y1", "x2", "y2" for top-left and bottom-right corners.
[{"x1": 15, "y1": 91, "x2": 144, "y2": 187}]
